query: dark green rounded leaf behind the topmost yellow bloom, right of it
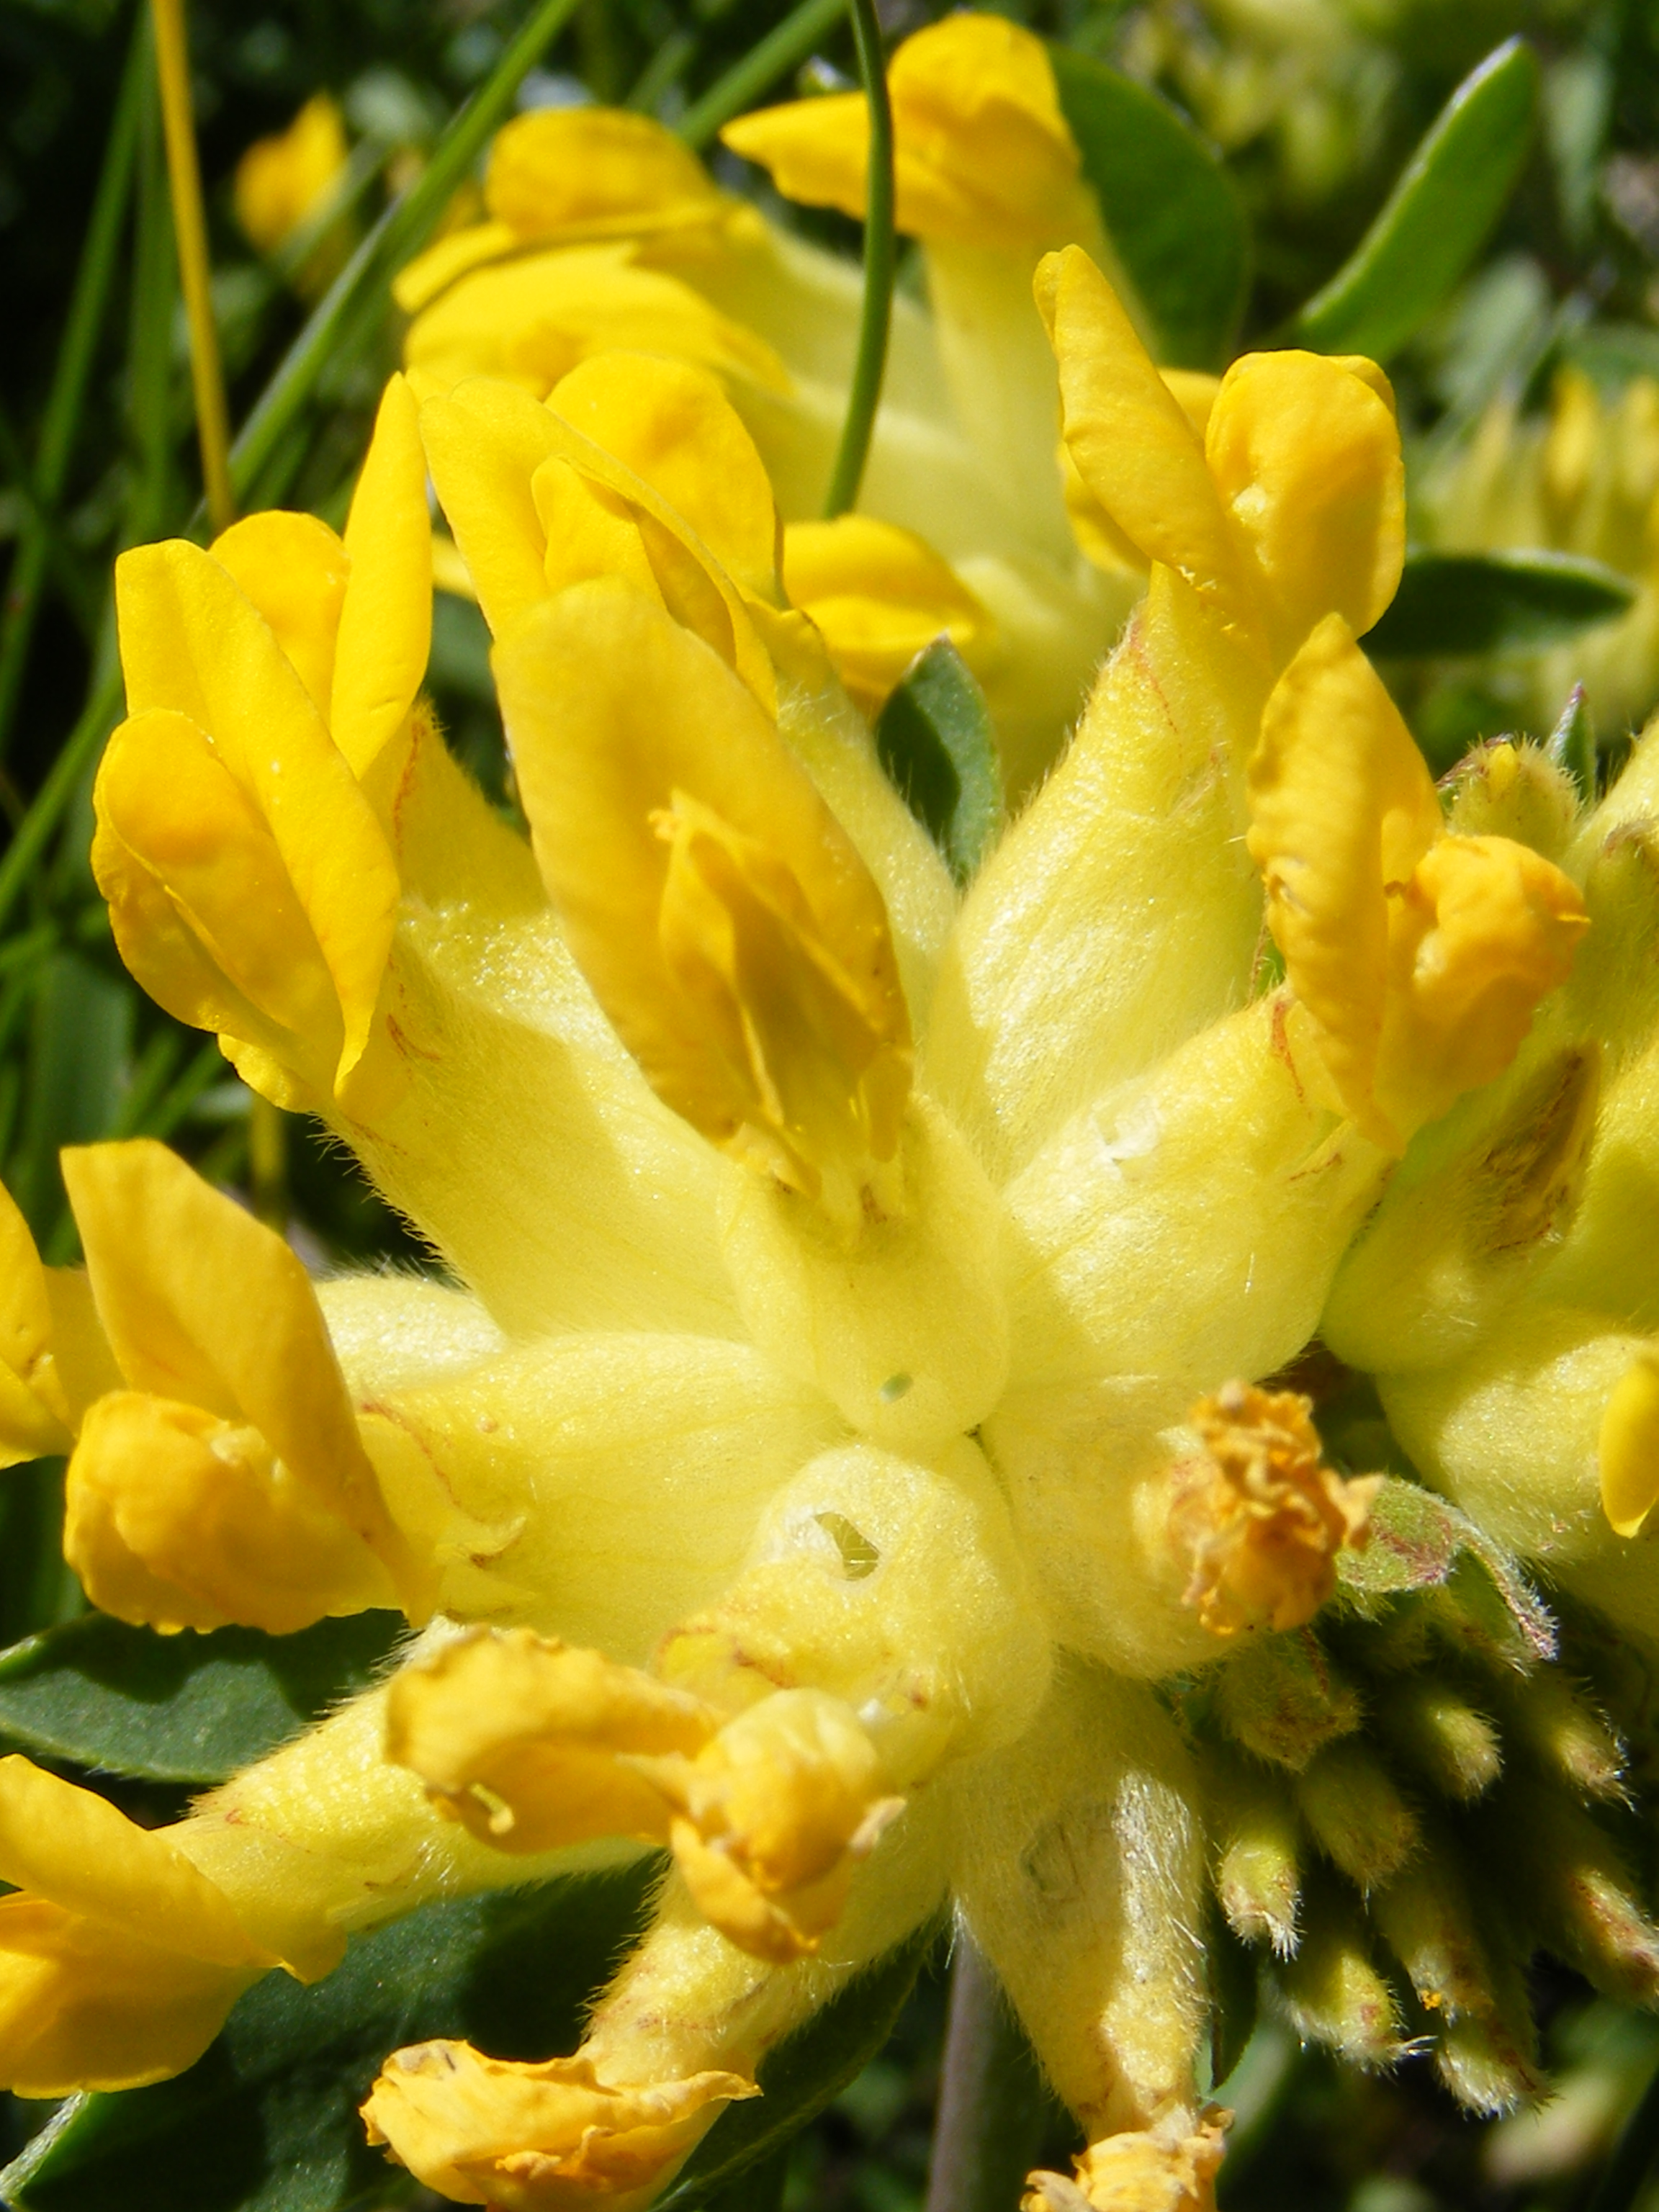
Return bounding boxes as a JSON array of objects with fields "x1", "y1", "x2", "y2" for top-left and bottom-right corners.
[{"x1": 1048, "y1": 47, "x2": 1250, "y2": 369}]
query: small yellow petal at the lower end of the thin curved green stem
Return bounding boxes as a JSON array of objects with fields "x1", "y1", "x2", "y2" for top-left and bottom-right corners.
[{"x1": 783, "y1": 516, "x2": 995, "y2": 714}]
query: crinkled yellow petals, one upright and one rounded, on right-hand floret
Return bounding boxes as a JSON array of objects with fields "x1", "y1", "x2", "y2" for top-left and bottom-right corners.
[{"x1": 1248, "y1": 615, "x2": 1588, "y2": 1150}]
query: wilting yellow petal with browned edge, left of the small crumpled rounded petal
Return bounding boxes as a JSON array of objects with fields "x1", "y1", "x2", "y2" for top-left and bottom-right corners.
[{"x1": 387, "y1": 1628, "x2": 716, "y2": 1851}]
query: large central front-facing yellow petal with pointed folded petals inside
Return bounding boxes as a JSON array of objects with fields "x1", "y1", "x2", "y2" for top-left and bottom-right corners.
[{"x1": 495, "y1": 582, "x2": 909, "y2": 1221}]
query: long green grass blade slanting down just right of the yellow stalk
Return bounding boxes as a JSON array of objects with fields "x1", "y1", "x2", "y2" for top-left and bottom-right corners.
[{"x1": 230, "y1": 0, "x2": 577, "y2": 498}]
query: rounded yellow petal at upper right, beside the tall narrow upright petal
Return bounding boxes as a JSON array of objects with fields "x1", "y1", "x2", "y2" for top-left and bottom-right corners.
[{"x1": 1205, "y1": 351, "x2": 1405, "y2": 666}]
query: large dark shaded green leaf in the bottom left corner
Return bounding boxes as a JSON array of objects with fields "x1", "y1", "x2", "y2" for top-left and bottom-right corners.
[{"x1": 0, "y1": 1858, "x2": 657, "y2": 2212}]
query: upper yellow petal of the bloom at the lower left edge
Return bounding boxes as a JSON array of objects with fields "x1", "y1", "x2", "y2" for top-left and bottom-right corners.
[{"x1": 0, "y1": 1756, "x2": 276, "y2": 1966}]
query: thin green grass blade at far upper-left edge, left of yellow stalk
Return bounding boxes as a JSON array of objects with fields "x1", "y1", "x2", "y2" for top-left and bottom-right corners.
[{"x1": 0, "y1": 18, "x2": 148, "y2": 759}]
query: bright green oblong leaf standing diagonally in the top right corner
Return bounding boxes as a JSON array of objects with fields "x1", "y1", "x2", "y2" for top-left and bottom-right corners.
[{"x1": 1292, "y1": 37, "x2": 1539, "y2": 361}]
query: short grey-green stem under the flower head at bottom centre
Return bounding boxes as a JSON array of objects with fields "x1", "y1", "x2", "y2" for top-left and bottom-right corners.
[{"x1": 925, "y1": 1929, "x2": 1044, "y2": 2212}]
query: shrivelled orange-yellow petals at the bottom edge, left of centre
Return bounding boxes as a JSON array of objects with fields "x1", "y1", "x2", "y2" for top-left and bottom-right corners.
[{"x1": 363, "y1": 2041, "x2": 759, "y2": 2212}]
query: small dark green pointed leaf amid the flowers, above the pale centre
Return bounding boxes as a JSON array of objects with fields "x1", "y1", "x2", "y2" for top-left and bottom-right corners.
[{"x1": 876, "y1": 637, "x2": 1002, "y2": 883}]
